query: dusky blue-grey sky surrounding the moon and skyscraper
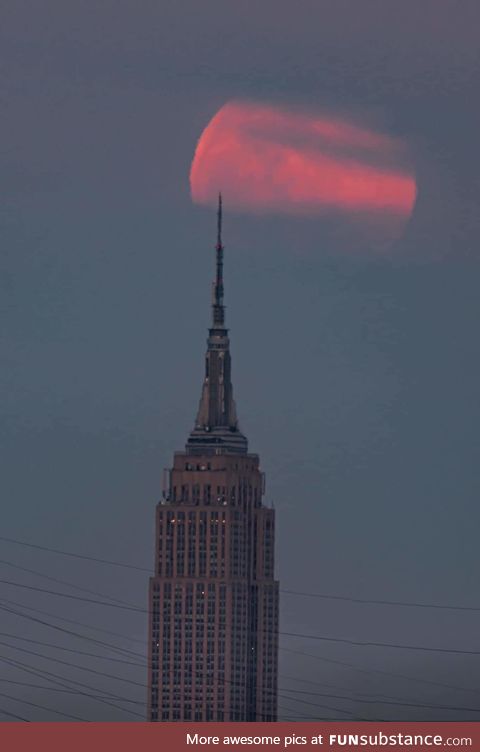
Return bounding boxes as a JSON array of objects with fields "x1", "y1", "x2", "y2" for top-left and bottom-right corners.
[{"x1": 0, "y1": 0, "x2": 480, "y2": 721}]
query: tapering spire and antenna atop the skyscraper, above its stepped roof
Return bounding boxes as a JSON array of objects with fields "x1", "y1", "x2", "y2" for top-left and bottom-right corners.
[{"x1": 187, "y1": 193, "x2": 247, "y2": 454}]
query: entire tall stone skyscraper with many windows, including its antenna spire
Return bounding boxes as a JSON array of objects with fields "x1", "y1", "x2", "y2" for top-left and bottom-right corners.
[{"x1": 148, "y1": 198, "x2": 278, "y2": 721}]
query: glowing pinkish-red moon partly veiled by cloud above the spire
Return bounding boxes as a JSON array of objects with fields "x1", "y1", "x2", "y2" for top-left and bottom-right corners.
[{"x1": 190, "y1": 101, "x2": 416, "y2": 250}]
